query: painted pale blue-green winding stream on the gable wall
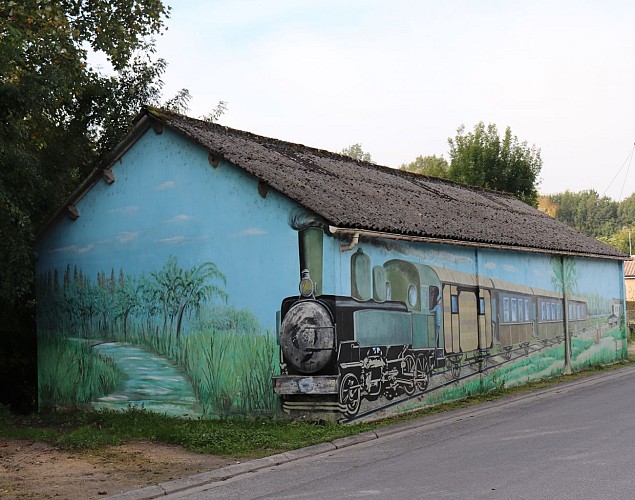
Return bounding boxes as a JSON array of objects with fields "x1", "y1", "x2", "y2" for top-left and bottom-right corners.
[{"x1": 93, "y1": 342, "x2": 202, "y2": 417}]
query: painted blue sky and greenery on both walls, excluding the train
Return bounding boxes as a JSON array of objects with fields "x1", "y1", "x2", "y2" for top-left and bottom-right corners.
[{"x1": 36, "y1": 129, "x2": 626, "y2": 417}]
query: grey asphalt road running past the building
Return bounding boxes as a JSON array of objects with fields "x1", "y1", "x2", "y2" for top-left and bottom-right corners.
[{"x1": 126, "y1": 367, "x2": 635, "y2": 500}]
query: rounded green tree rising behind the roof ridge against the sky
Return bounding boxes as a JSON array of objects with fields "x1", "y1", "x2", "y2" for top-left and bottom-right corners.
[{"x1": 448, "y1": 122, "x2": 542, "y2": 206}]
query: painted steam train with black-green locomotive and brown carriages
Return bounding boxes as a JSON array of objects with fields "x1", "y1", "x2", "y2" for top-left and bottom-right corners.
[{"x1": 274, "y1": 229, "x2": 587, "y2": 419}]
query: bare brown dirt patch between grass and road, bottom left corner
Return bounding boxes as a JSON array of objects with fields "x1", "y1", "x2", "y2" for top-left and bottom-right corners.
[{"x1": 0, "y1": 438, "x2": 236, "y2": 500}]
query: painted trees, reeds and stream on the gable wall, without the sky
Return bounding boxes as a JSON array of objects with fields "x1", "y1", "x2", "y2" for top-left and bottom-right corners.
[{"x1": 37, "y1": 255, "x2": 278, "y2": 416}]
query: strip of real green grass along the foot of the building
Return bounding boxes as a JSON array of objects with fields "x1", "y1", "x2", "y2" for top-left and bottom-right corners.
[{"x1": 0, "y1": 360, "x2": 632, "y2": 457}]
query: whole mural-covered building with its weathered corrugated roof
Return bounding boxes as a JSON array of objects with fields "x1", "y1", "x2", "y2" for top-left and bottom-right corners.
[{"x1": 36, "y1": 108, "x2": 626, "y2": 419}]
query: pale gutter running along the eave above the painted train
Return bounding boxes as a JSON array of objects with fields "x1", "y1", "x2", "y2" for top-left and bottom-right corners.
[{"x1": 329, "y1": 226, "x2": 628, "y2": 261}]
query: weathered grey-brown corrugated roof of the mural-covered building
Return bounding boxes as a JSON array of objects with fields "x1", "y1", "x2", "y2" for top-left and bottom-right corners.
[{"x1": 128, "y1": 108, "x2": 626, "y2": 258}]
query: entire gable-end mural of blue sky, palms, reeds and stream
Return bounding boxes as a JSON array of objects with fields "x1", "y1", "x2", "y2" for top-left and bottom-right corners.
[{"x1": 36, "y1": 129, "x2": 308, "y2": 417}]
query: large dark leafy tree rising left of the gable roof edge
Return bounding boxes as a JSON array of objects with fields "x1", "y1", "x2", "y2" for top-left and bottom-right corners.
[{"x1": 0, "y1": 0, "x2": 169, "y2": 304}]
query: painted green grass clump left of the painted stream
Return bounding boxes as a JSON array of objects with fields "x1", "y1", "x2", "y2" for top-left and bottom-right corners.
[{"x1": 38, "y1": 334, "x2": 125, "y2": 408}]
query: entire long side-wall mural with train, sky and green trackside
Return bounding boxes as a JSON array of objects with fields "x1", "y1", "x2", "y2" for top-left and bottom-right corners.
[{"x1": 274, "y1": 227, "x2": 626, "y2": 420}]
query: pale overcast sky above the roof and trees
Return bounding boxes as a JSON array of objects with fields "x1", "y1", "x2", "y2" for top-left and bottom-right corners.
[{"x1": 150, "y1": 0, "x2": 635, "y2": 201}]
